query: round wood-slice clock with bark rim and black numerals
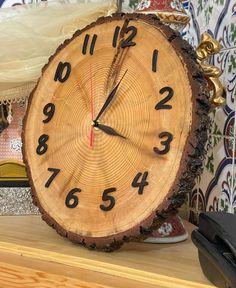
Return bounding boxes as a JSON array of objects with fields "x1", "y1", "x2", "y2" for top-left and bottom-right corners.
[{"x1": 23, "y1": 14, "x2": 209, "y2": 251}]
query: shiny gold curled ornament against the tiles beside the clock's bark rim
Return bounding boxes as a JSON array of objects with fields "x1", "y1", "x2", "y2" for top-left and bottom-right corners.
[{"x1": 196, "y1": 32, "x2": 226, "y2": 106}]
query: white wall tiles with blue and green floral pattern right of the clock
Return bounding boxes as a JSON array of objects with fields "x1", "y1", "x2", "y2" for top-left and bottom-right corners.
[{"x1": 185, "y1": 0, "x2": 236, "y2": 223}]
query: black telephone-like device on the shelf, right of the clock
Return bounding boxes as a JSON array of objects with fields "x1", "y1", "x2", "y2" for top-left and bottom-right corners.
[{"x1": 192, "y1": 212, "x2": 236, "y2": 288}]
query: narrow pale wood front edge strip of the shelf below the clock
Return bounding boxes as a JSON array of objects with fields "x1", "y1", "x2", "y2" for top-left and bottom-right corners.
[{"x1": 0, "y1": 242, "x2": 212, "y2": 288}]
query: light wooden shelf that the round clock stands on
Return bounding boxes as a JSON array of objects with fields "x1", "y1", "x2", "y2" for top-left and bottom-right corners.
[{"x1": 0, "y1": 216, "x2": 215, "y2": 288}]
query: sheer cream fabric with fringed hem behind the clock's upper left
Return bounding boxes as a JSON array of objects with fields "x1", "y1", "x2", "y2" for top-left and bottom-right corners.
[{"x1": 0, "y1": 0, "x2": 116, "y2": 104}]
